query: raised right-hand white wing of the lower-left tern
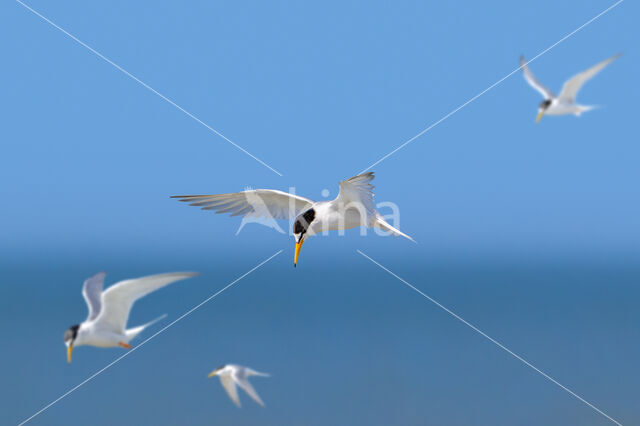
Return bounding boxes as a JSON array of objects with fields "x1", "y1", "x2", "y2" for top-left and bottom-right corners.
[{"x1": 96, "y1": 272, "x2": 197, "y2": 333}]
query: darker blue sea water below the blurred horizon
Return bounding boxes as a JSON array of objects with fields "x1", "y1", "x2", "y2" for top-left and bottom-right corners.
[{"x1": 0, "y1": 253, "x2": 640, "y2": 425}]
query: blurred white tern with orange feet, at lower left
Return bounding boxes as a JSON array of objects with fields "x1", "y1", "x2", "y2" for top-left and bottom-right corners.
[{"x1": 64, "y1": 272, "x2": 197, "y2": 362}]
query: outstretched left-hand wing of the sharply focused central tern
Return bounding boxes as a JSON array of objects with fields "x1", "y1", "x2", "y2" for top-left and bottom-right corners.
[{"x1": 171, "y1": 189, "x2": 313, "y2": 220}]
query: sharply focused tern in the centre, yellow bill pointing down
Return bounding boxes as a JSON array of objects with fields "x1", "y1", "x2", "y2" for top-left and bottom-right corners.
[{"x1": 171, "y1": 172, "x2": 413, "y2": 266}]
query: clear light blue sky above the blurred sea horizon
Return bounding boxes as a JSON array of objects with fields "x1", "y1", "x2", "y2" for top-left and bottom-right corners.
[{"x1": 0, "y1": 2, "x2": 640, "y2": 264}]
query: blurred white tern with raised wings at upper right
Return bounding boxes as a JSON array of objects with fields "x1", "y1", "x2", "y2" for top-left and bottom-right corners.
[{"x1": 520, "y1": 53, "x2": 621, "y2": 123}]
